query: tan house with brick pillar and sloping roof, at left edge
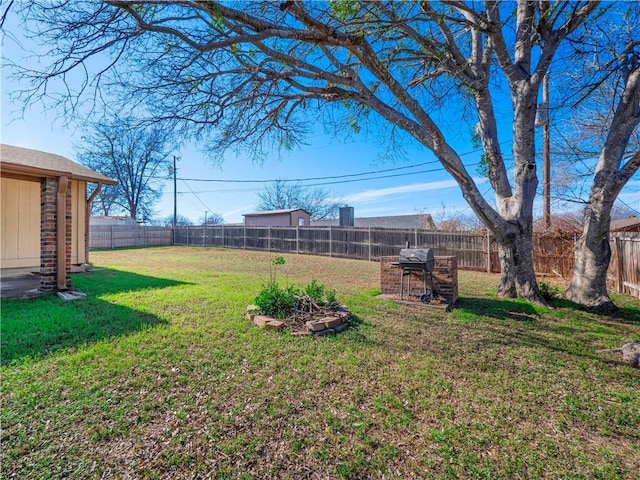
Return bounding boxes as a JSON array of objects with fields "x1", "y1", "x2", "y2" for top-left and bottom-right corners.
[{"x1": 0, "y1": 145, "x2": 116, "y2": 291}]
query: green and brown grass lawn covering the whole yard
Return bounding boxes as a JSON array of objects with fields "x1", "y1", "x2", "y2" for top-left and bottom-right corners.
[{"x1": 1, "y1": 247, "x2": 640, "y2": 479}]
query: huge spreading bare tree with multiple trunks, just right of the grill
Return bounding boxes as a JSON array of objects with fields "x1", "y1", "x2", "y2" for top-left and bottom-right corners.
[{"x1": 8, "y1": 0, "x2": 626, "y2": 304}]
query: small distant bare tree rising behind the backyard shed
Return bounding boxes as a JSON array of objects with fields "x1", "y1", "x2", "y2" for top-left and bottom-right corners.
[{"x1": 256, "y1": 180, "x2": 340, "y2": 220}]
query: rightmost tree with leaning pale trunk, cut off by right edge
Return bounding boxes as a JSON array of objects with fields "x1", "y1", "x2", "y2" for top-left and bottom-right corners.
[{"x1": 544, "y1": 15, "x2": 640, "y2": 309}]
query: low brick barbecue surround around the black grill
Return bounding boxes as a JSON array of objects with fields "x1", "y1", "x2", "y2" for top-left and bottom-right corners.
[{"x1": 380, "y1": 256, "x2": 458, "y2": 305}]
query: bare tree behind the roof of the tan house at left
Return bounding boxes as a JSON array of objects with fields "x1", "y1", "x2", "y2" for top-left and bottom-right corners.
[{"x1": 76, "y1": 119, "x2": 174, "y2": 220}]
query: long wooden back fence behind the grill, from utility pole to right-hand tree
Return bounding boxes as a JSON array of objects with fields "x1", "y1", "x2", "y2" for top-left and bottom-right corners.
[{"x1": 169, "y1": 225, "x2": 574, "y2": 277}]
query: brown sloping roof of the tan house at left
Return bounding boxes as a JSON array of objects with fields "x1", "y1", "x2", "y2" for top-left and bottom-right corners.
[{"x1": 0, "y1": 144, "x2": 117, "y2": 185}]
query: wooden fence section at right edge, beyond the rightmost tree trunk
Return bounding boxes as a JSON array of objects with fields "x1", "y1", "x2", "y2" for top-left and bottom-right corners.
[{"x1": 607, "y1": 232, "x2": 640, "y2": 298}]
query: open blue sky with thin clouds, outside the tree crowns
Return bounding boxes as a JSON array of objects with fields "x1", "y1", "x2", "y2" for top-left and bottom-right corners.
[{"x1": 0, "y1": 5, "x2": 640, "y2": 223}]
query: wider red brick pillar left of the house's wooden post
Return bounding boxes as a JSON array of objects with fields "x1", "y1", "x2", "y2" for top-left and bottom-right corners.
[{"x1": 40, "y1": 177, "x2": 58, "y2": 292}]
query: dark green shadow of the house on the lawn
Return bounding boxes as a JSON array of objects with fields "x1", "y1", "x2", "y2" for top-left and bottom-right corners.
[{"x1": 0, "y1": 269, "x2": 189, "y2": 365}]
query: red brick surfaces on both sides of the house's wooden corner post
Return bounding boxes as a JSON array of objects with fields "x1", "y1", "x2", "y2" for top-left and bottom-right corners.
[{"x1": 40, "y1": 177, "x2": 72, "y2": 292}]
